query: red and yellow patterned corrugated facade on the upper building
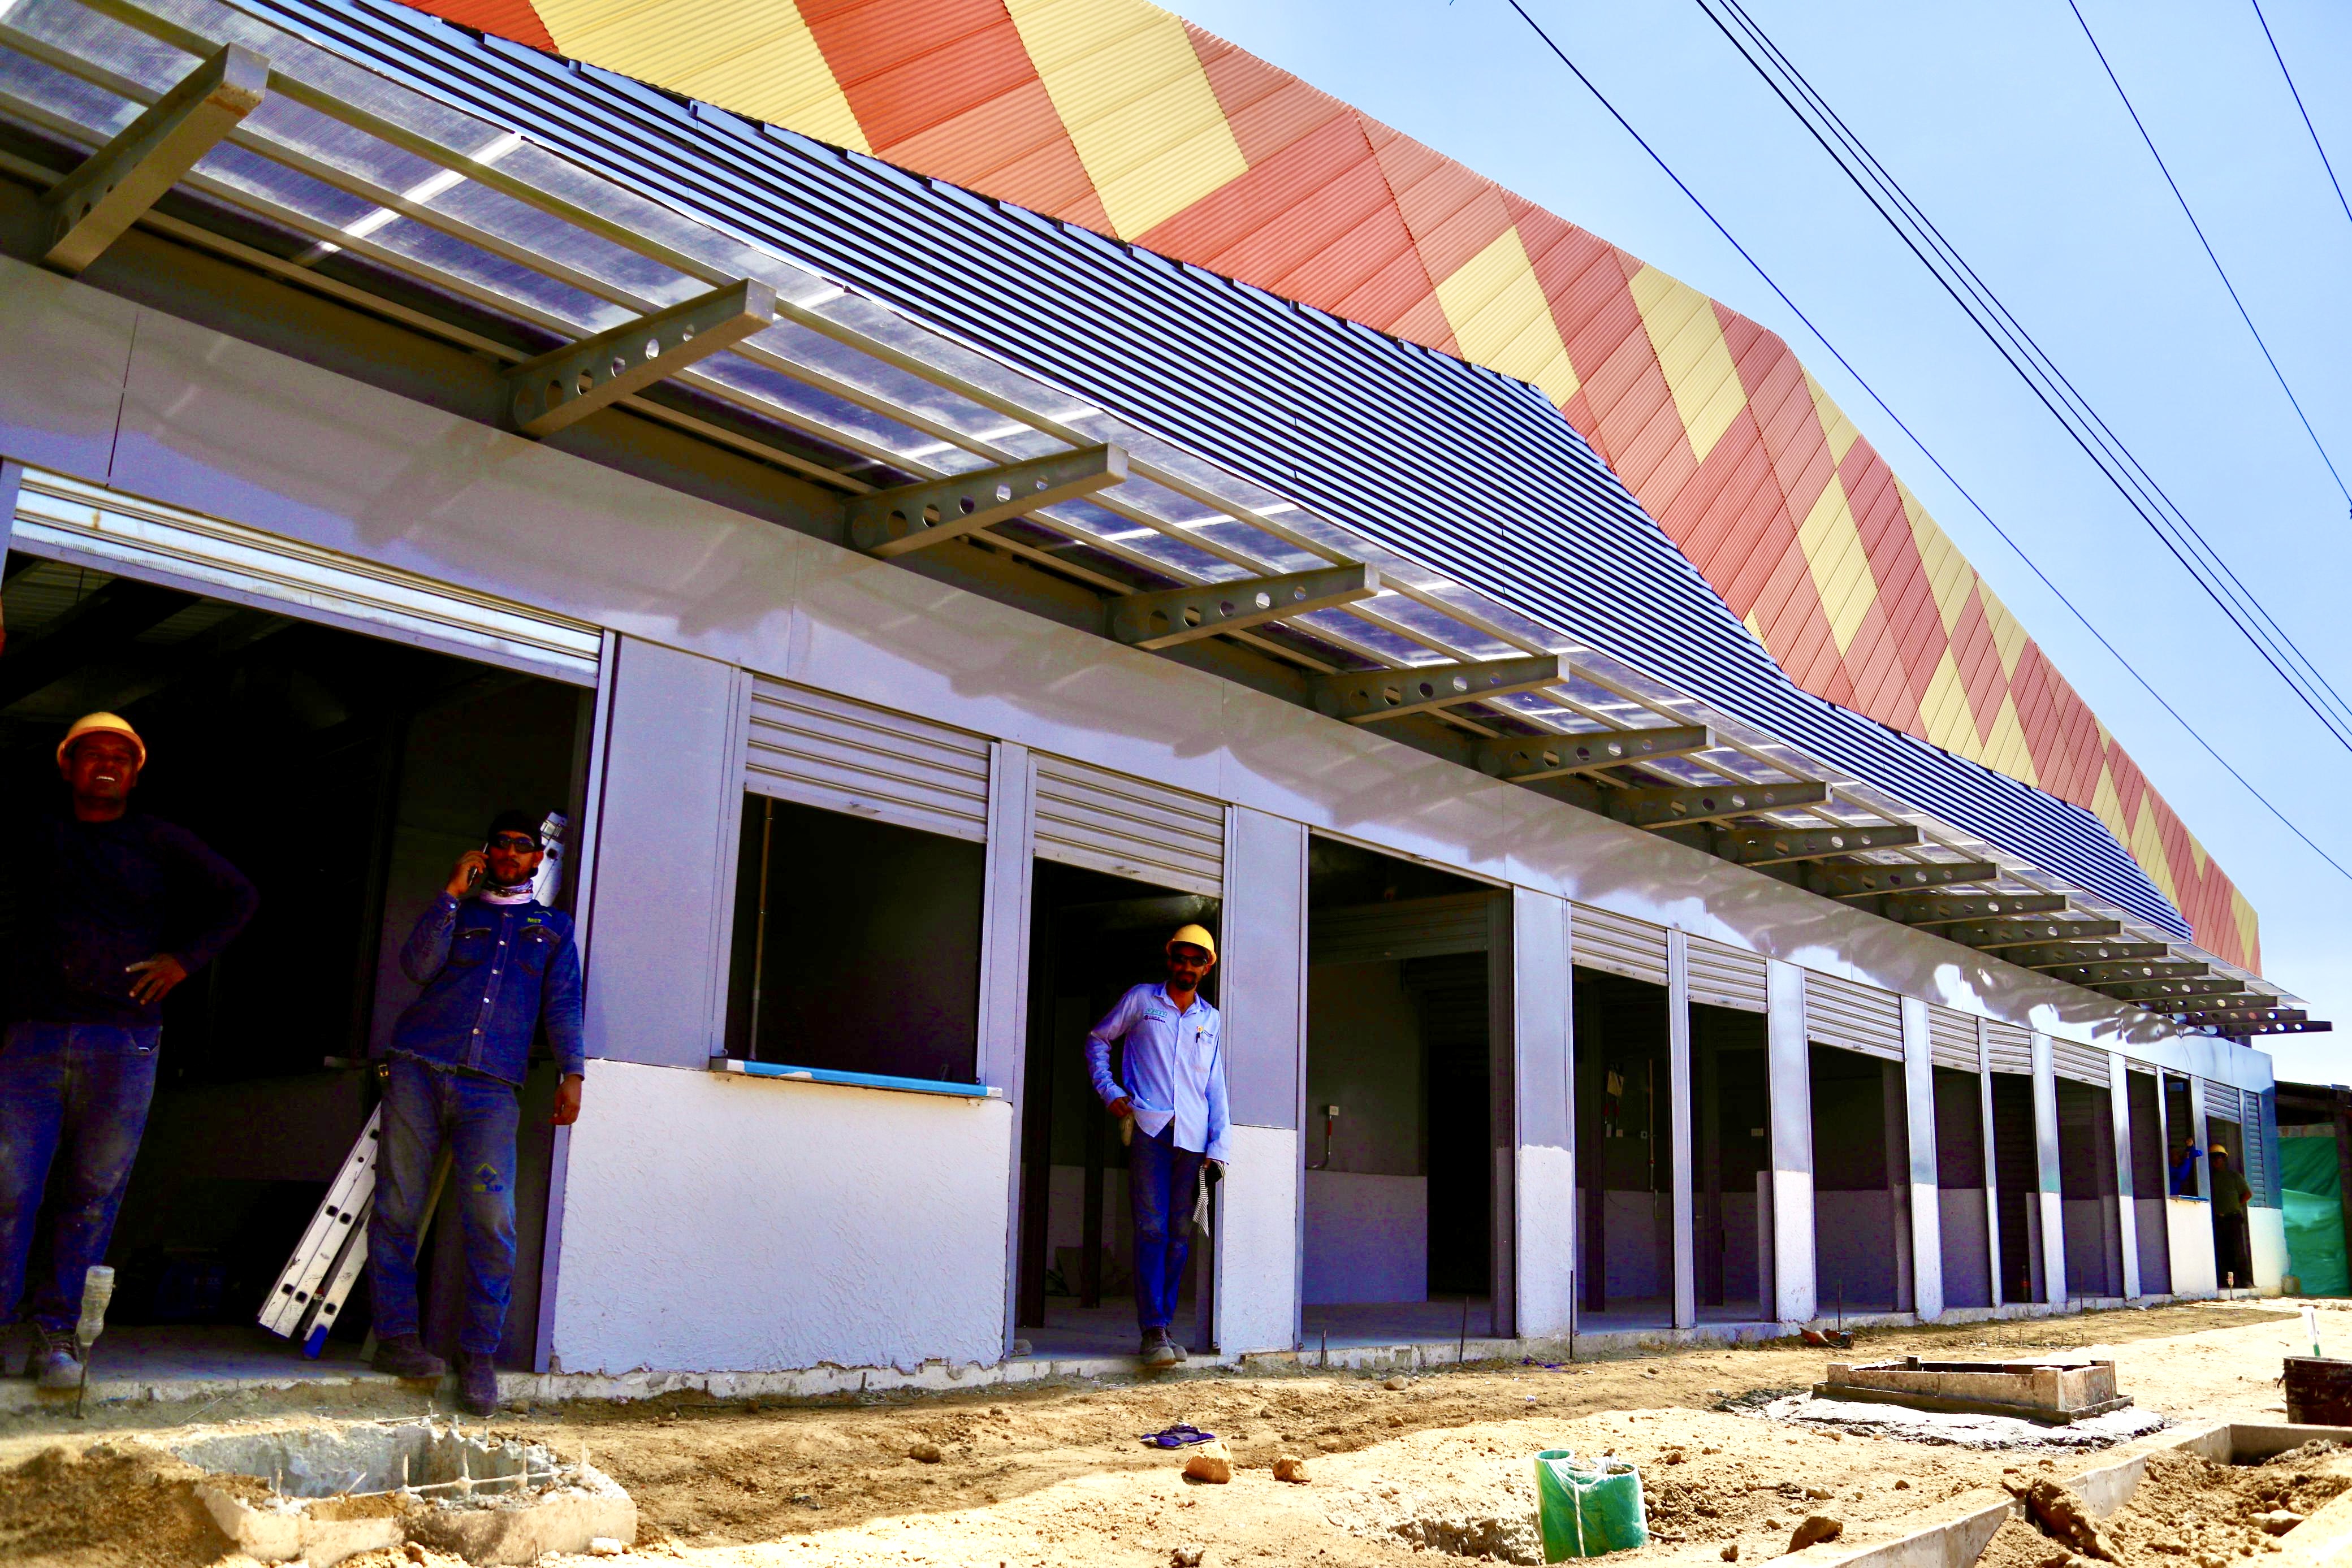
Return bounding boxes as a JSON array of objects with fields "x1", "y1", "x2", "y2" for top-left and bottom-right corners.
[{"x1": 404, "y1": 0, "x2": 2260, "y2": 966}]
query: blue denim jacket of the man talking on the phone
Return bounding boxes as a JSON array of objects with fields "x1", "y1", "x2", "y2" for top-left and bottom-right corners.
[{"x1": 391, "y1": 893, "x2": 588, "y2": 1084}]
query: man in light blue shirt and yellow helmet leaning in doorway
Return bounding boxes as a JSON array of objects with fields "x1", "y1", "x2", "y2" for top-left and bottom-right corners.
[{"x1": 1087, "y1": 926, "x2": 1228, "y2": 1366}]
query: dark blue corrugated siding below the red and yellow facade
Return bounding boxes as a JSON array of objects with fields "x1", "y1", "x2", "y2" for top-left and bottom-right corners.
[{"x1": 242, "y1": 0, "x2": 2190, "y2": 935}]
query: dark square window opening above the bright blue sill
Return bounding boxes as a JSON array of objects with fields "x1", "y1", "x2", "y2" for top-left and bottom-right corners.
[{"x1": 727, "y1": 795, "x2": 985, "y2": 1084}]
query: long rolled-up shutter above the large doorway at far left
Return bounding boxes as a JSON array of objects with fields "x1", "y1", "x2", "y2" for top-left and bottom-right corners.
[{"x1": 10, "y1": 468, "x2": 604, "y2": 686}]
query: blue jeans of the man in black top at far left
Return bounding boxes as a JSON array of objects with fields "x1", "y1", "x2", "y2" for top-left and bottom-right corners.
[{"x1": 0, "y1": 1023, "x2": 162, "y2": 1333}]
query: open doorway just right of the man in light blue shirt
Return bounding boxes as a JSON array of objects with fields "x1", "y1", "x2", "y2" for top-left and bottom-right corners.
[{"x1": 1300, "y1": 837, "x2": 1515, "y2": 1345}]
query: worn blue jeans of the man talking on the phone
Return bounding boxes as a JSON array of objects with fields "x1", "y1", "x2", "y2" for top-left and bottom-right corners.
[{"x1": 367, "y1": 1055, "x2": 522, "y2": 1357}]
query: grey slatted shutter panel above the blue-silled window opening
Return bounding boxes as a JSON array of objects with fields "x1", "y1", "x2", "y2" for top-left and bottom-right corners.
[{"x1": 743, "y1": 679, "x2": 988, "y2": 842}]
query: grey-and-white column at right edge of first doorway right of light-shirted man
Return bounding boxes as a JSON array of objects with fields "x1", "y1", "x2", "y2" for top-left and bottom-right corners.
[{"x1": 1510, "y1": 889, "x2": 1576, "y2": 1340}]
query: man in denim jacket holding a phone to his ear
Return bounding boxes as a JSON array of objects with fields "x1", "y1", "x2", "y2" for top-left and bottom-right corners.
[{"x1": 367, "y1": 811, "x2": 586, "y2": 1415}]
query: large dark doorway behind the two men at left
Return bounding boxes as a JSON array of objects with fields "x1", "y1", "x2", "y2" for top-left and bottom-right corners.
[{"x1": 0, "y1": 552, "x2": 590, "y2": 1375}]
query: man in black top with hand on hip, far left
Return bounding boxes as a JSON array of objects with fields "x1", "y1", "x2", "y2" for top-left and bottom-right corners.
[{"x1": 0, "y1": 712, "x2": 258, "y2": 1389}]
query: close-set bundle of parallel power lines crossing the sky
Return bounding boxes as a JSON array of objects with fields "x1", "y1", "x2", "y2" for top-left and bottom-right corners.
[{"x1": 1698, "y1": 0, "x2": 2352, "y2": 750}]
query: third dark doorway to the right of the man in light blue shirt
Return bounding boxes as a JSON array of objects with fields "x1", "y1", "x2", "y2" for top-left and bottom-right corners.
[{"x1": 1691, "y1": 1004, "x2": 1771, "y2": 1319}]
